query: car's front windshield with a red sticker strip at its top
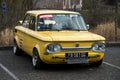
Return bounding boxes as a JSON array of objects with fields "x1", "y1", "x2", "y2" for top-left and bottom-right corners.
[{"x1": 37, "y1": 14, "x2": 87, "y2": 31}]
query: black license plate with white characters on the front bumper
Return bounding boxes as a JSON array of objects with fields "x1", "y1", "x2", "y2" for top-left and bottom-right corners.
[{"x1": 65, "y1": 52, "x2": 88, "y2": 59}]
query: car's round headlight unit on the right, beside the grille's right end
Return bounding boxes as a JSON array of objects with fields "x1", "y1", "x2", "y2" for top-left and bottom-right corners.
[{"x1": 92, "y1": 43, "x2": 105, "y2": 52}]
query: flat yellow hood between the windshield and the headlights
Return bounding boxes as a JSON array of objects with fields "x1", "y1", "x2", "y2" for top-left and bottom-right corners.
[{"x1": 38, "y1": 31, "x2": 105, "y2": 41}]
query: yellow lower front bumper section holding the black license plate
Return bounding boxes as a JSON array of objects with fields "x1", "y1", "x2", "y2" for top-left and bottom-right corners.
[{"x1": 41, "y1": 51, "x2": 104, "y2": 64}]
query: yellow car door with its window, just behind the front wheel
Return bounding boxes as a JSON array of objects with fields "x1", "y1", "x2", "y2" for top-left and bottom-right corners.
[{"x1": 24, "y1": 15, "x2": 36, "y2": 55}]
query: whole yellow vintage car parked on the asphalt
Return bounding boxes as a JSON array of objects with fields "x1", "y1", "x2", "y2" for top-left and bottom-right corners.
[{"x1": 13, "y1": 10, "x2": 105, "y2": 69}]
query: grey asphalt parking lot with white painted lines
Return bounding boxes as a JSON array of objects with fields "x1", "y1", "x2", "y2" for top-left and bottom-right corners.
[{"x1": 0, "y1": 47, "x2": 120, "y2": 80}]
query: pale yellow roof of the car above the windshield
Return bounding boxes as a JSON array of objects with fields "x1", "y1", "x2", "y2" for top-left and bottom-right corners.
[{"x1": 27, "y1": 10, "x2": 80, "y2": 15}]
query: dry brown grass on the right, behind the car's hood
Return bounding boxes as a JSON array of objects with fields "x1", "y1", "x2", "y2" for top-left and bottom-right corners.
[{"x1": 90, "y1": 22, "x2": 120, "y2": 41}]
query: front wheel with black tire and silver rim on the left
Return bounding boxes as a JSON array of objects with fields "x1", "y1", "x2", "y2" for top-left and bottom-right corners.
[{"x1": 32, "y1": 49, "x2": 44, "y2": 69}]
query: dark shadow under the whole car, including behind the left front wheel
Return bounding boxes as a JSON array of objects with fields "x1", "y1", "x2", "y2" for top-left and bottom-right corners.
[{"x1": 13, "y1": 53, "x2": 101, "y2": 71}]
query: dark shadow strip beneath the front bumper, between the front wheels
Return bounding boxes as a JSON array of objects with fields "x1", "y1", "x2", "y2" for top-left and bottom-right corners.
[{"x1": 34, "y1": 64, "x2": 97, "y2": 71}]
